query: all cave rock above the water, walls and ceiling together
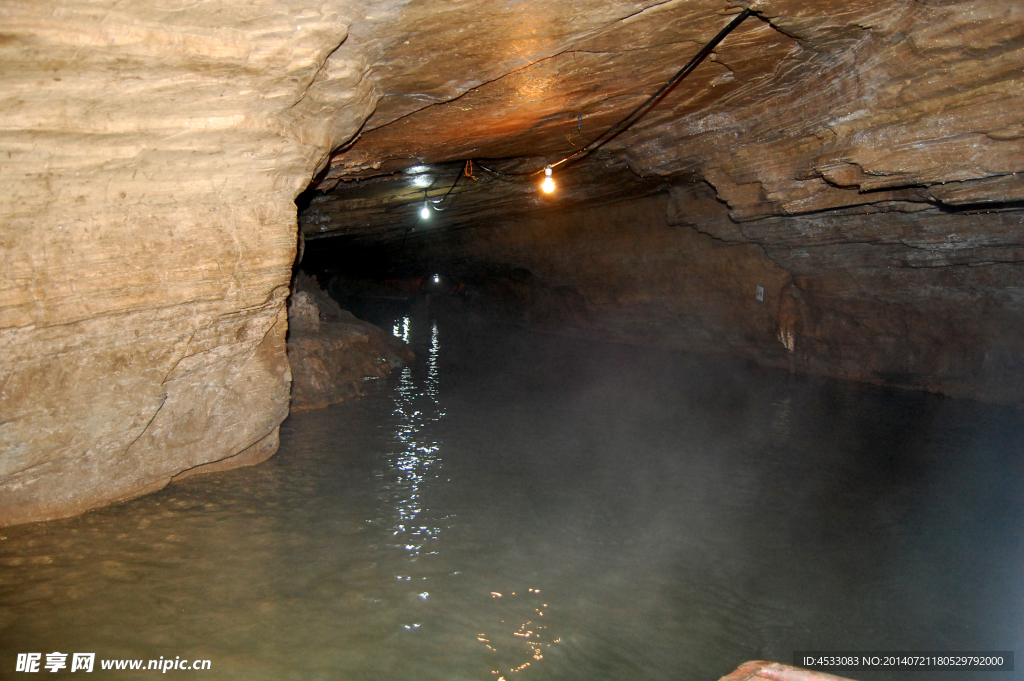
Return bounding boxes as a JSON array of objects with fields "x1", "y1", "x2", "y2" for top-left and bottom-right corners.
[{"x1": 0, "y1": 0, "x2": 1024, "y2": 678}]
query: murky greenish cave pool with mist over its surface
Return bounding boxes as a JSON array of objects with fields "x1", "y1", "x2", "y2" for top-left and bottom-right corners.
[{"x1": 0, "y1": 315, "x2": 1024, "y2": 681}]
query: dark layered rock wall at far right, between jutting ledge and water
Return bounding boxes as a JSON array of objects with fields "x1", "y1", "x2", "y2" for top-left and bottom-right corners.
[{"x1": 742, "y1": 209, "x2": 1024, "y2": 405}]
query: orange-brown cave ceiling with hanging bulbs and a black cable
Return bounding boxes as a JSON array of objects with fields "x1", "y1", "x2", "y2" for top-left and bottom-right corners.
[{"x1": 300, "y1": 0, "x2": 1024, "y2": 240}]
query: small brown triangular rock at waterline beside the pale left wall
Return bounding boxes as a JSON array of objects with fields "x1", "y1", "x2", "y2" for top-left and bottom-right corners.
[{"x1": 288, "y1": 272, "x2": 413, "y2": 412}]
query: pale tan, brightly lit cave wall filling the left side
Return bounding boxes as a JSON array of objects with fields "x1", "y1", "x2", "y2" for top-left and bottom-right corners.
[{"x1": 0, "y1": 0, "x2": 373, "y2": 524}]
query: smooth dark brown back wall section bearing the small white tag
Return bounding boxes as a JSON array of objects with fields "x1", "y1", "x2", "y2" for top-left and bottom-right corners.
[{"x1": 432, "y1": 195, "x2": 790, "y2": 364}]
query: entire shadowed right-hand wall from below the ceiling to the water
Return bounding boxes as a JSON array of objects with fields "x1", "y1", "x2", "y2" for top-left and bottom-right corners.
[{"x1": 432, "y1": 188, "x2": 1024, "y2": 405}]
